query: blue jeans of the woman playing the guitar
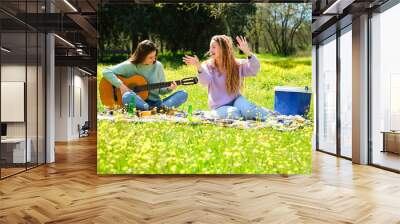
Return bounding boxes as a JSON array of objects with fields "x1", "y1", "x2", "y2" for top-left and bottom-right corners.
[{"x1": 122, "y1": 90, "x2": 188, "y2": 110}]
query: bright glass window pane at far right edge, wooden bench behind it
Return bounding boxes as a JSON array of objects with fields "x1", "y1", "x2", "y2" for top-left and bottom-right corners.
[{"x1": 371, "y1": 4, "x2": 400, "y2": 170}]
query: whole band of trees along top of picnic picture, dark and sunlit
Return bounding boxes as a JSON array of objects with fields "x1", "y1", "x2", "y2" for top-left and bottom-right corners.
[{"x1": 98, "y1": 3, "x2": 311, "y2": 63}]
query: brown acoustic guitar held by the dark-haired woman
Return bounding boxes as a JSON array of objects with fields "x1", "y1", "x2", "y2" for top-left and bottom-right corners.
[{"x1": 99, "y1": 75, "x2": 198, "y2": 108}]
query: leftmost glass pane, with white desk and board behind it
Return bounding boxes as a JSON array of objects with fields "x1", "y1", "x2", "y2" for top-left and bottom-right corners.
[{"x1": 0, "y1": 32, "x2": 27, "y2": 177}]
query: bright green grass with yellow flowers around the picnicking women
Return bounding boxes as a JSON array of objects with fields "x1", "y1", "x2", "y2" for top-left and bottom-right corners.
[{"x1": 97, "y1": 54, "x2": 312, "y2": 174}]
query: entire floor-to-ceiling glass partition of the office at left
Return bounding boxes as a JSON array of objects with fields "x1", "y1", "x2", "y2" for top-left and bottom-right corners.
[{"x1": 0, "y1": 0, "x2": 46, "y2": 178}]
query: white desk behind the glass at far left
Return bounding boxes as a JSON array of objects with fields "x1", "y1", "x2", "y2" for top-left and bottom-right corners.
[{"x1": 1, "y1": 138, "x2": 32, "y2": 163}]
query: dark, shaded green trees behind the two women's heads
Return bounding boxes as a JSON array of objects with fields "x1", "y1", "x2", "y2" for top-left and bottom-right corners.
[{"x1": 99, "y1": 3, "x2": 253, "y2": 62}]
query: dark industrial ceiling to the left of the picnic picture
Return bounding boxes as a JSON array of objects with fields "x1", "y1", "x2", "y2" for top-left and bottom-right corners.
[{"x1": 0, "y1": 0, "x2": 98, "y2": 74}]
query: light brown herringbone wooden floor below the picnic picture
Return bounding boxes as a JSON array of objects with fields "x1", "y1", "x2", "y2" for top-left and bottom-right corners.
[{"x1": 0, "y1": 134, "x2": 400, "y2": 224}]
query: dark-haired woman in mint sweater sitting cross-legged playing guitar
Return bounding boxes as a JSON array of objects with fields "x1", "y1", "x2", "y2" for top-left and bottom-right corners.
[{"x1": 103, "y1": 40, "x2": 188, "y2": 110}]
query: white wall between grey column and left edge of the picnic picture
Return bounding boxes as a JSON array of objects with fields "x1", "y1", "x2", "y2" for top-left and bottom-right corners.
[{"x1": 55, "y1": 67, "x2": 88, "y2": 141}]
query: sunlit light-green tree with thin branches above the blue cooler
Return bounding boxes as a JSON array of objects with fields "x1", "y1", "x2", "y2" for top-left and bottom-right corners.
[{"x1": 247, "y1": 3, "x2": 312, "y2": 56}]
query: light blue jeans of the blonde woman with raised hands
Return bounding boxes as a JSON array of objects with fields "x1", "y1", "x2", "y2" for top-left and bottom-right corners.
[{"x1": 213, "y1": 95, "x2": 273, "y2": 121}]
